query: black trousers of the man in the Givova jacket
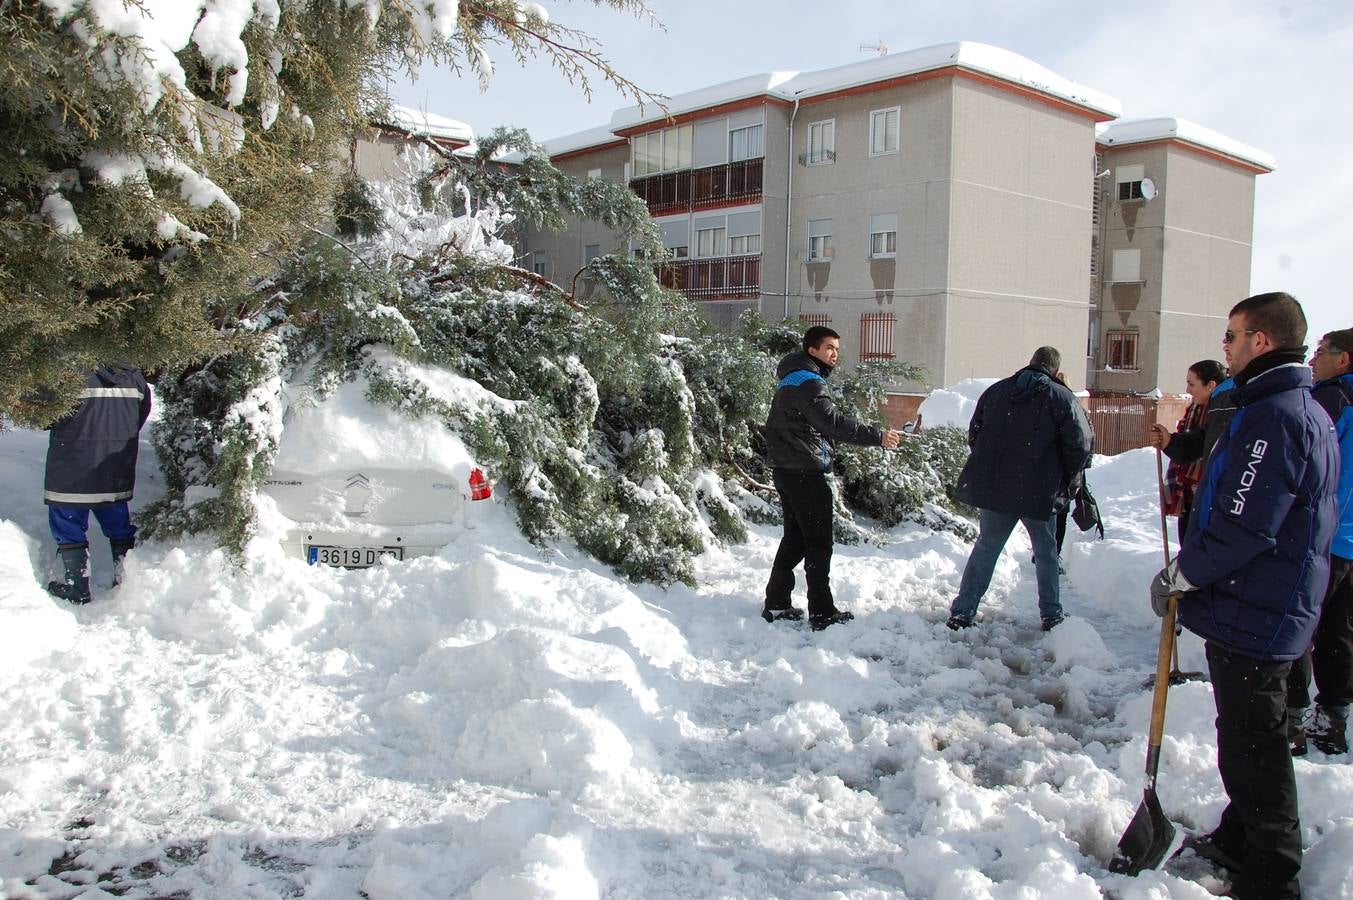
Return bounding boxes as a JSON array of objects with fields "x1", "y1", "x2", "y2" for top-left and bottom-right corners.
[{"x1": 1207, "y1": 642, "x2": 1302, "y2": 900}]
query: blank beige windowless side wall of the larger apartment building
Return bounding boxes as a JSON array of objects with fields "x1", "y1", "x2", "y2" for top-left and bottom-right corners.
[{"x1": 943, "y1": 78, "x2": 1095, "y2": 388}]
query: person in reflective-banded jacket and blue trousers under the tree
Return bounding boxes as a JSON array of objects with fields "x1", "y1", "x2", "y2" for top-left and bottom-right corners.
[{"x1": 43, "y1": 365, "x2": 150, "y2": 604}]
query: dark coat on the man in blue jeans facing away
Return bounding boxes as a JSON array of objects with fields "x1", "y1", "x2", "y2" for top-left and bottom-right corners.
[{"x1": 954, "y1": 365, "x2": 1095, "y2": 518}]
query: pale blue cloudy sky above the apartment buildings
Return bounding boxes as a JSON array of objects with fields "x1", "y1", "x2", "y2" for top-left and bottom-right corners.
[{"x1": 391, "y1": 0, "x2": 1353, "y2": 365}]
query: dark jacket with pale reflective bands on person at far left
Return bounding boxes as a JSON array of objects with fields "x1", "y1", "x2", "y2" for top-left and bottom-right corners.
[{"x1": 42, "y1": 365, "x2": 150, "y2": 509}]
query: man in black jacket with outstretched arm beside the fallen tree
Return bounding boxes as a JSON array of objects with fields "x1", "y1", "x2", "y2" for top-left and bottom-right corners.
[{"x1": 762, "y1": 325, "x2": 902, "y2": 631}]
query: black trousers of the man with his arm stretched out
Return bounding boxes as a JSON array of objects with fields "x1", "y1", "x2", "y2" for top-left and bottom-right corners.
[{"x1": 766, "y1": 468, "x2": 836, "y2": 616}]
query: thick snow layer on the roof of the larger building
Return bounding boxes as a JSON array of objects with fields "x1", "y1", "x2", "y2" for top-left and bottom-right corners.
[{"x1": 610, "y1": 41, "x2": 1123, "y2": 131}]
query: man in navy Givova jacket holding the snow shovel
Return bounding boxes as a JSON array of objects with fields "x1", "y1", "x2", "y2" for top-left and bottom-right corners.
[{"x1": 1151, "y1": 294, "x2": 1339, "y2": 900}]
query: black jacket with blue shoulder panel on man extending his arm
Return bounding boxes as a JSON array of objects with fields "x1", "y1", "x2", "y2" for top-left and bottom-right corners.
[{"x1": 766, "y1": 352, "x2": 884, "y2": 472}]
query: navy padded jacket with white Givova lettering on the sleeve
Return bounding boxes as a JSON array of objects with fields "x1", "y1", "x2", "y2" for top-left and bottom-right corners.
[{"x1": 1178, "y1": 351, "x2": 1339, "y2": 660}]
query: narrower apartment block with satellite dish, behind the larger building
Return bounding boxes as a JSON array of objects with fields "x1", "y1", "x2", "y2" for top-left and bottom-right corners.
[{"x1": 1089, "y1": 118, "x2": 1273, "y2": 392}]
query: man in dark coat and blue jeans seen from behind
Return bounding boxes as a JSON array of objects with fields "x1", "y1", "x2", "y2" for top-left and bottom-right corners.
[{"x1": 946, "y1": 346, "x2": 1095, "y2": 631}]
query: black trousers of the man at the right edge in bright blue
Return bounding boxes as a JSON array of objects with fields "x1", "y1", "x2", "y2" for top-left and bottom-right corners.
[{"x1": 1287, "y1": 556, "x2": 1353, "y2": 709}]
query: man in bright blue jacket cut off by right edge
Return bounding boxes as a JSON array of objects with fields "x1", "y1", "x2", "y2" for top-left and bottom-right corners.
[{"x1": 1287, "y1": 328, "x2": 1353, "y2": 754}]
